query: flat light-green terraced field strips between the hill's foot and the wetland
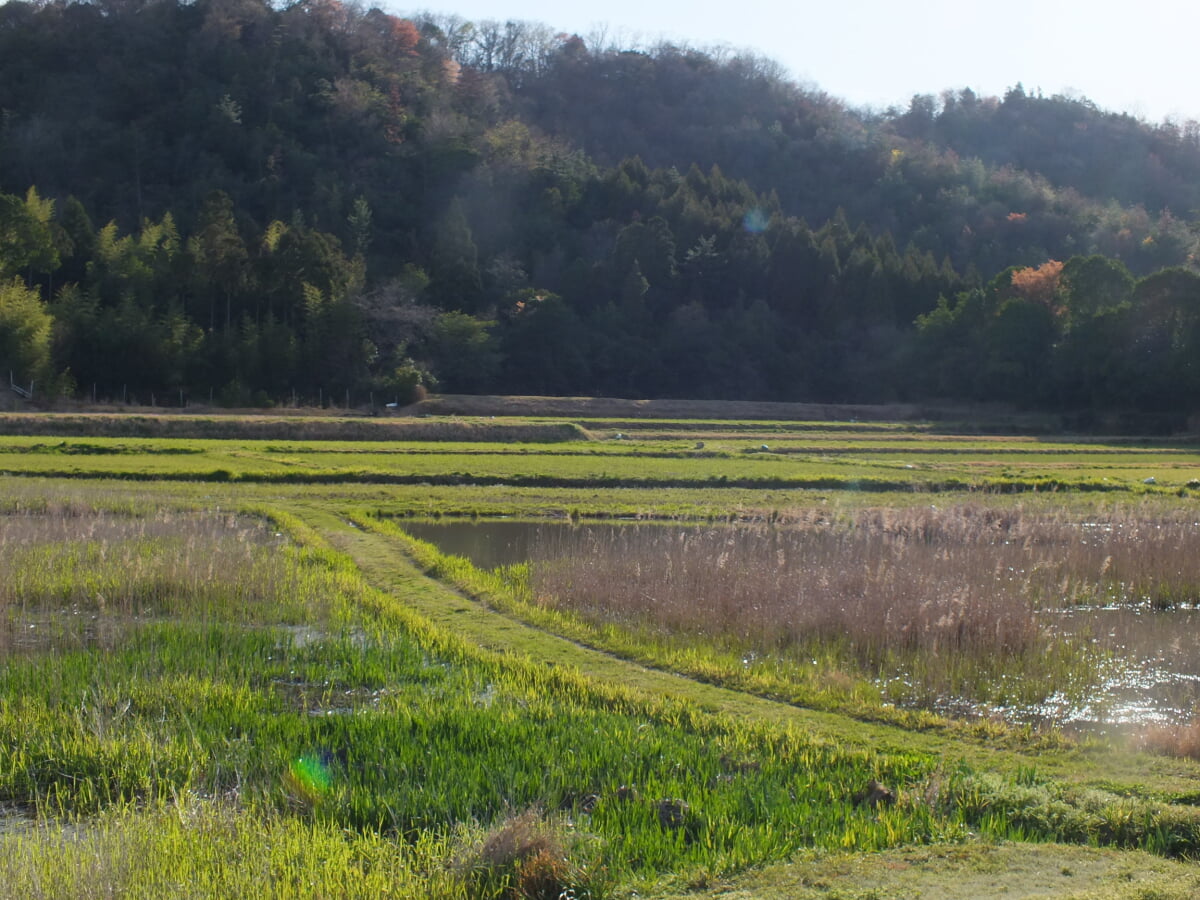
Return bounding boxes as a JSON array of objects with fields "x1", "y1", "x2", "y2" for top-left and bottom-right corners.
[{"x1": 0, "y1": 421, "x2": 1200, "y2": 493}]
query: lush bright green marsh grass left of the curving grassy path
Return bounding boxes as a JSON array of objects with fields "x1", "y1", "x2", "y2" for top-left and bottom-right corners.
[{"x1": 0, "y1": 508, "x2": 960, "y2": 897}]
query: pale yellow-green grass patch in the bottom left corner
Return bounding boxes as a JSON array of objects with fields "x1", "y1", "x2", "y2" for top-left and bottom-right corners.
[{"x1": 0, "y1": 797, "x2": 464, "y2": 900}]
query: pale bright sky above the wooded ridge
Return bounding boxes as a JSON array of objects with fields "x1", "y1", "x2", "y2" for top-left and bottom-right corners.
[{"x1": 398, "y1": 0, "x2": 1200, "y2": 122}]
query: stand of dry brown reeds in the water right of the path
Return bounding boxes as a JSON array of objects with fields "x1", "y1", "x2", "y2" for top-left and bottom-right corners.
[{"x1": 532, "y1": 505, "x2": 1200, "y2": 710}]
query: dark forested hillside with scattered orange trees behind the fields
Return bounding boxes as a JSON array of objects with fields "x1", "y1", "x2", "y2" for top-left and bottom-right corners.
[{"x1": 0, "y1": 0, "x2": 1200, "y2": 420}]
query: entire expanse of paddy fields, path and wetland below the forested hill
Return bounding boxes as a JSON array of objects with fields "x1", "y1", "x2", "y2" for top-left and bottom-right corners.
[{"x1": 0, "y1": 414, "x2": 1200, "y2": 899}]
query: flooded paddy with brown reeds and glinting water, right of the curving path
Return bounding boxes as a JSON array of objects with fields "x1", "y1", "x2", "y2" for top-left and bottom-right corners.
[{"x1": 403, "y1": 517, "x2": 1200, "y2": 731}]
